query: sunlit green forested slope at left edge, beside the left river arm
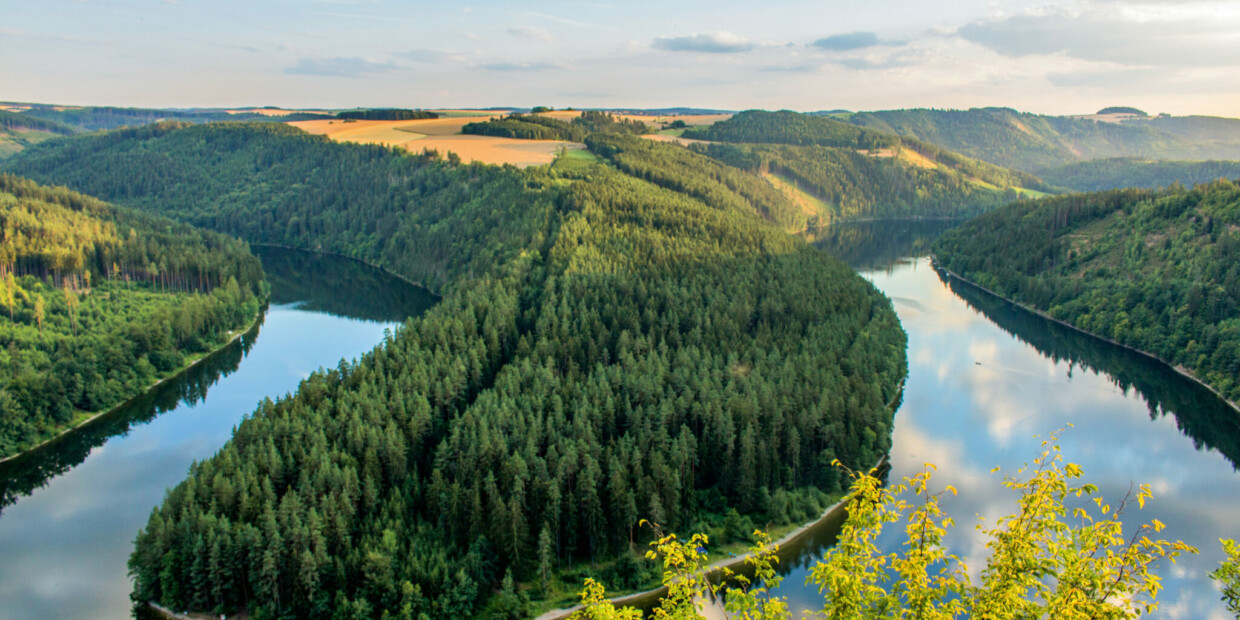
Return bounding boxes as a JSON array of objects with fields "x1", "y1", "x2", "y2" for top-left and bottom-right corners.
[{"x1": 0, "y1": 175, "x2": 263, "y2": 458}]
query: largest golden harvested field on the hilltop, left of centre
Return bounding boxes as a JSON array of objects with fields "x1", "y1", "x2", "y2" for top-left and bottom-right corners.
[{"x1": 289, "y1": 112, "x2": 585, "y2": 167}]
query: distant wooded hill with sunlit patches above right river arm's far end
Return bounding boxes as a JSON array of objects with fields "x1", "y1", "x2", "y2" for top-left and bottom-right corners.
[{"x1": 684, "y1": 110, "x2": 1050, "y2": 224}]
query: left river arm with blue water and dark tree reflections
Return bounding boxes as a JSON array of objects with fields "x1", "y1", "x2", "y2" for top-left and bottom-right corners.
[{"x1": 0, "y1": 248, "x2": 435, "y2": 620}]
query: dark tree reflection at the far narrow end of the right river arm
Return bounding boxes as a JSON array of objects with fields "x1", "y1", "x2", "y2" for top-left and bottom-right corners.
[{"x1": 813, "y1": 219, "x2": 960, "y2": 272}]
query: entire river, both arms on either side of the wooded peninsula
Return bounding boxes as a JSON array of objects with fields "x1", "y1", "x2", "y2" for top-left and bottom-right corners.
[{"x1": 0, "y1": 228, "x2": 1240, "y2": 620}]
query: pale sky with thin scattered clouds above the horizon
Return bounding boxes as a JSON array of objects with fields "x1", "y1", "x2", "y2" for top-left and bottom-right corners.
[{"x1": 0, "y1": 0, "x2": 1240, "y2": 117}]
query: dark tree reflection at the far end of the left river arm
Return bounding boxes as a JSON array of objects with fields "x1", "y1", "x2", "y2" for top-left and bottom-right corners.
[{"x1": 253, "y1": 246, "x2": 438, "y2": 322}]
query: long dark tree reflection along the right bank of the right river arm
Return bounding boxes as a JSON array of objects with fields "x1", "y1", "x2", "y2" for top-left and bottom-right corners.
[{"x1": 939, "y1": 273, "x2": 1240, "y2": 469}]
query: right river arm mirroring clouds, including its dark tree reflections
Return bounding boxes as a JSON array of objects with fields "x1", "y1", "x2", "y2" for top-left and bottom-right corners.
[{"x1": 758, "y1": 224, "x2": 1240, "y2": 619}]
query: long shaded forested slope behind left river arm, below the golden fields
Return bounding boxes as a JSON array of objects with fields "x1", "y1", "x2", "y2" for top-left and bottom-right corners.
[{"x1": 7, "y1": 123, "x2": 548, "y2": 291}]
